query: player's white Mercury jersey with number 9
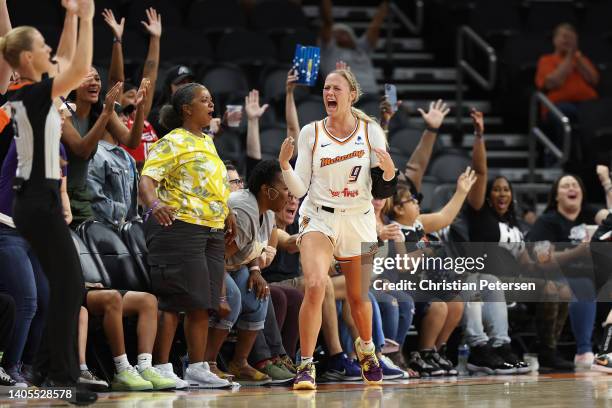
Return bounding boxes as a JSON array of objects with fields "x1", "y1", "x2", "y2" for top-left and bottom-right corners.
[{"x1": 306, "y1": 119, "x2": 373, "y2": 210}]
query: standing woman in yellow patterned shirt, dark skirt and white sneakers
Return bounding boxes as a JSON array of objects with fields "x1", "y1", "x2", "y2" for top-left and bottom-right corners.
[{"x1": 140, "y1": 83, "x2": 234, "y2": 388}]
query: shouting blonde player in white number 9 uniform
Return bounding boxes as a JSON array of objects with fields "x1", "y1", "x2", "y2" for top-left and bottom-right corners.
[{"x1": 279, "y1": 69, "x2": 397, "y2": 390}]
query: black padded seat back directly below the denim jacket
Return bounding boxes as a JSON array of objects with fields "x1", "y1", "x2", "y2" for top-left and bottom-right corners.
[{"x1": 78, "y1": 221, "x2": 150, "y2": 292}]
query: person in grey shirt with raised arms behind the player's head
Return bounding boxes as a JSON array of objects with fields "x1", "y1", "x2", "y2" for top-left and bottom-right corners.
[{"x1": 319, "y1": 0, "x2": 389, "y2": 95}]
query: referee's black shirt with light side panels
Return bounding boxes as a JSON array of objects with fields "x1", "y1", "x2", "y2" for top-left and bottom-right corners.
[{"x1": 9, "y1": 78, "x2": 62, "y2": 182}]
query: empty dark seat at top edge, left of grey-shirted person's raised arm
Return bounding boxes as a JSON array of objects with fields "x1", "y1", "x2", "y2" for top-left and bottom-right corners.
[{"x1": 250, "y1": 0, "x2": 309, "y2": 32}]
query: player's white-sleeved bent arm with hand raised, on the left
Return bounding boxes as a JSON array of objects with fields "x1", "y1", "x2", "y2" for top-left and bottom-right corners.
[{"x1": 278, "y1": 124, "x2": 314, "y2": 198}]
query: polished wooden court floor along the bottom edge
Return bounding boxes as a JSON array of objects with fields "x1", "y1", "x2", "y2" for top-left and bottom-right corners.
[{"x1": 0, "y1": 372, "x2": 612, "y2": 408}]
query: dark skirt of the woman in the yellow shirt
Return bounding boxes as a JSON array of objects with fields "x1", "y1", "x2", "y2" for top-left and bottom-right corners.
[{"x1": 145, "y1": 217, "x2": 225, "y2": 312}]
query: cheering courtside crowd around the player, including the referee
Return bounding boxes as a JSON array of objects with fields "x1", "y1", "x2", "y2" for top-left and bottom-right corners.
[{"x1": 0, "y1": 0, "x2": 612, "y2": 398}]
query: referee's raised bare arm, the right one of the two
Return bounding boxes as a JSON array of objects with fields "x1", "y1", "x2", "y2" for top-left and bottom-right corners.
[{"x1": 51, "y1": 0, "x2": 95, "y2": 99}]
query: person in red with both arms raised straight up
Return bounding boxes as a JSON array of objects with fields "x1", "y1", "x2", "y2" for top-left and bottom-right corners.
[{"x1": 102, "y1": 7, "x2": 162, "y2": 171}]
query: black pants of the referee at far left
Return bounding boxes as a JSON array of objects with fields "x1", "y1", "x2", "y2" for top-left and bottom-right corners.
[{"x1": 13, "y1": 182, "x2": 85, "y2": 384}]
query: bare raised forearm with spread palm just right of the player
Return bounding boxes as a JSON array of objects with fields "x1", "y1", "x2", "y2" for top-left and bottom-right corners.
[{"x1": 404, "y1": 99, "x2": 450, "y2": 190}]
